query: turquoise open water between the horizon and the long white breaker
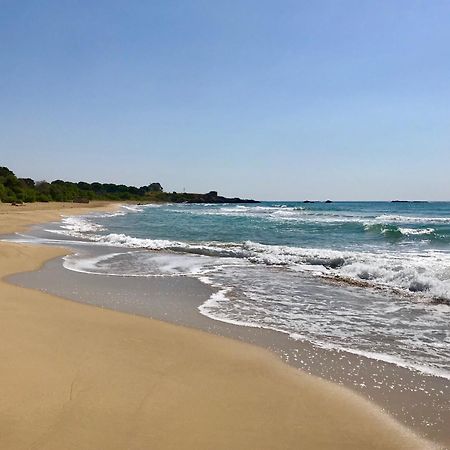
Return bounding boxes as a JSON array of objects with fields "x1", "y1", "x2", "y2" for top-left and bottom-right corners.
[{"x1": 96, "y1": 202, "x2": 450, "y2": 250}]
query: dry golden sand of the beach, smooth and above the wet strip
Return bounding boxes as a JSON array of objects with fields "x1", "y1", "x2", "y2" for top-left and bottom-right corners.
[{"x1": 0, "y1": 204, "x2": 436, "y2": 450}]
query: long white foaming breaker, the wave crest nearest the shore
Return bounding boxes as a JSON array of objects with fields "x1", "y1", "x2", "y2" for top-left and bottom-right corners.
[{"x1": 55, "y1": 218, "x2": 450, "y2": 300}]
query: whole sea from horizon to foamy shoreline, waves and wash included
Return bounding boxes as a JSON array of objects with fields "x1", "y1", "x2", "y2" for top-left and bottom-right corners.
[{"x1": 37, "y1": 201, "x2": 450, "y2": 379}]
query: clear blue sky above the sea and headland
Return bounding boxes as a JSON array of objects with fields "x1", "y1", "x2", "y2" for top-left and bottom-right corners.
[{"x1": 0, "y1": 0, "x2": 450, "y2": 200}]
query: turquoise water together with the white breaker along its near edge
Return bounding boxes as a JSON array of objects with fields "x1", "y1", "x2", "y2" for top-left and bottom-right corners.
[{"x1": 85, "y1": 202, "x2": 450, "y2": 300}]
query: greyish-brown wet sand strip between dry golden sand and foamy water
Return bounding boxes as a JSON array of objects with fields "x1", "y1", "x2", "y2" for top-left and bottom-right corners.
[{"x1": 8, "y1": 239, "x2": 450, "y2": 445}]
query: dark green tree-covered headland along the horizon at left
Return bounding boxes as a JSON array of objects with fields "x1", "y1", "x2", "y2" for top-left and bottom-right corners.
[{"x1": 0, "y1": 167, "x2": 259, "y2": 204}]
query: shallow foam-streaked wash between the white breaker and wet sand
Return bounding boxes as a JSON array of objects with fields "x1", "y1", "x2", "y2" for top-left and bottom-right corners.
[{"x1": 199, "y1": 266, "x2": 450, "y2": 378}]
